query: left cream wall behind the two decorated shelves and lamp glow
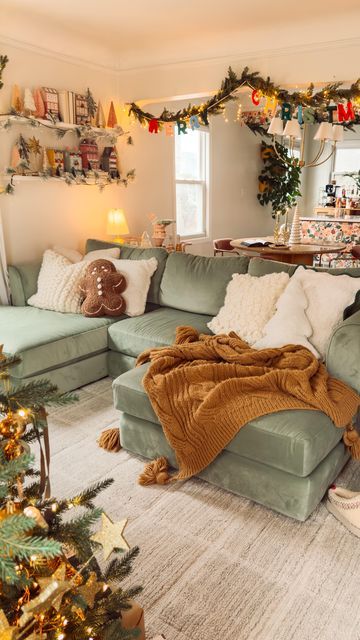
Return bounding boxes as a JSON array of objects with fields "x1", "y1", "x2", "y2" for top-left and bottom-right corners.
[{"x1": 0, "y1": 43, "x2": 131, "y2": 263}]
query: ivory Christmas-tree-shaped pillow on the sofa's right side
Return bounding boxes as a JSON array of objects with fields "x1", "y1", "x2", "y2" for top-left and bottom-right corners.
[{"x1": 253, "y1": 276, "x2": 319, "y2": 358}]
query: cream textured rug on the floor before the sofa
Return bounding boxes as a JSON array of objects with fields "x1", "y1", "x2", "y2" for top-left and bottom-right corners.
[{"x1": 49, "y1": 379, "x2": 360, "y2": 640}]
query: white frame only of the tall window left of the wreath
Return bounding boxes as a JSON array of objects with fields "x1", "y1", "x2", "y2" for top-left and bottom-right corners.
[{"x1": 173, "y1": 127, "x2": 210, "y2": 242}]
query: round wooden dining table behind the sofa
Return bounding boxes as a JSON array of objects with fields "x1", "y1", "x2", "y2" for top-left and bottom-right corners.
[{"x1": 230, "y1": 236, "x2": 347, "y2": 265}]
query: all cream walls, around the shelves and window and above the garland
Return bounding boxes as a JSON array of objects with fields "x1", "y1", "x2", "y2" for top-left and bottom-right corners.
[{"x1": 0, "y1": 35, "x2": 360, "y2": 262}]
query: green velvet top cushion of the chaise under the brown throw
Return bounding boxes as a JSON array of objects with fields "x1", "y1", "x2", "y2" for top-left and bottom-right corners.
[{"x1": 113, "y1": 365, "x2": 343, "y2": 476}]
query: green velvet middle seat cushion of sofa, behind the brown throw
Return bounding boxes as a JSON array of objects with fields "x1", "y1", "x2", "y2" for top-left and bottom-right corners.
[{"x1": 109, "y1": 308, "x2": 211, "y2": 357}]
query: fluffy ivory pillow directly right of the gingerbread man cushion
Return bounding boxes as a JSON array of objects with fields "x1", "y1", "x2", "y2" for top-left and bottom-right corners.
[{"x1": 110, "y1": 258, "x2": 158, "y2": 316}]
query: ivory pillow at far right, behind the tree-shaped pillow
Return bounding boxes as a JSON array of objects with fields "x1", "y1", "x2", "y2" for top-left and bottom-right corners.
[{"x1": 291, "y1": 267, "x2": 360, "y2": 359}]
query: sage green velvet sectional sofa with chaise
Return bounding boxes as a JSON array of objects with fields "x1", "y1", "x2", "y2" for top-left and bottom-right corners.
[{"x1": 0, "y1": 240, "x2": 360, "y2": 520}]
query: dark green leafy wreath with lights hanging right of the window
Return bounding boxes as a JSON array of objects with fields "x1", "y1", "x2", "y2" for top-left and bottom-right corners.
[{"x1": 257, "y1": 141, "x2": 301, "y2": 218}]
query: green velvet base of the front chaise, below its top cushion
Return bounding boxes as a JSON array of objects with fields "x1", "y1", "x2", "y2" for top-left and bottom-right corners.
[{"x1": 120, "y1": 414, "x2": 349, "y2": 521}]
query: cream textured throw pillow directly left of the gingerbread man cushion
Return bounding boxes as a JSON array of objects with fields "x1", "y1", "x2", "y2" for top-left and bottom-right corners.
[{"x1": 28, "y1": 249, "x2": 88, "y2": 313}]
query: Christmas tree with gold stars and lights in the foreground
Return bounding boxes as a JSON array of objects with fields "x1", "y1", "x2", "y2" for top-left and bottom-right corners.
[{"x1": 0, "y1": 347, "x2": 141, "y2": 640}]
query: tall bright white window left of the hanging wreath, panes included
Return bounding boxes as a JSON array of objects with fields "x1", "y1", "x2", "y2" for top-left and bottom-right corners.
[{"x1": 175, "y1": 130, "x2": 209, "y2": 238}]
